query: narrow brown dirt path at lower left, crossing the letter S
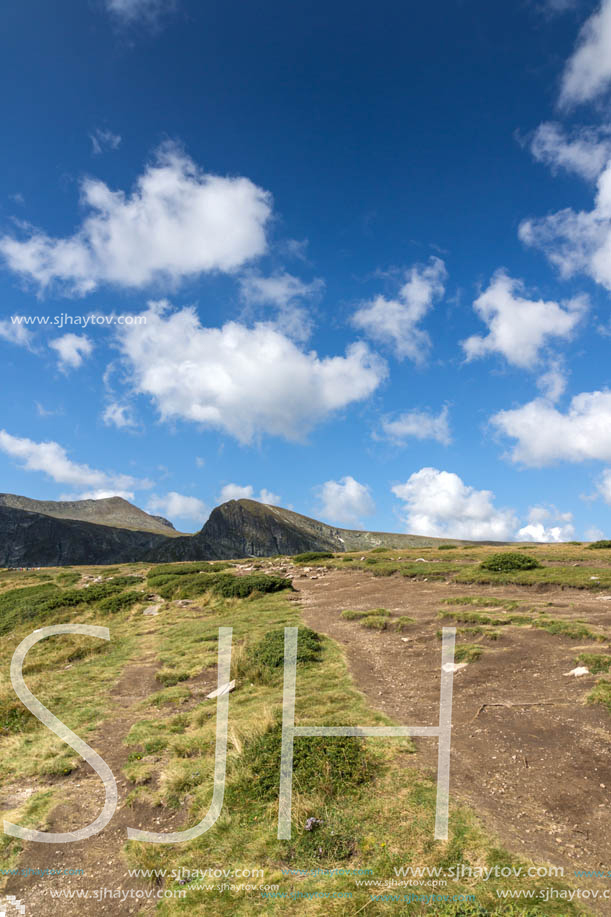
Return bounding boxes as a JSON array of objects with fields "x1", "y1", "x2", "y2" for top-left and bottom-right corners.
[{"x1": 5, "y1": 641, "x2": 189, "y2": 917}]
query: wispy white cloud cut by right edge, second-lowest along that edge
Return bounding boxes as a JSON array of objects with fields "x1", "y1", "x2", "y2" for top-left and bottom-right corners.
[{"x1": 518, "y1": 156, "x2": 611, "y2": 290}]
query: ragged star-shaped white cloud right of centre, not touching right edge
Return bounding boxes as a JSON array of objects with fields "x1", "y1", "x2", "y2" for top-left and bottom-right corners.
[{"x1": 462, "y1": 270, "x2": 587, "y2": 369}]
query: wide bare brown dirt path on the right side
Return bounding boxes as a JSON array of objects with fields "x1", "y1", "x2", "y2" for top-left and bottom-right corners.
[{"x1": 295, "y1": 570, "x2": 611, "y2": 887}]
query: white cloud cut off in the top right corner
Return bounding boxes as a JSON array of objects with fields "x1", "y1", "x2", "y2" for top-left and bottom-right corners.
[{"x1": 560, "y1": 0, "x2": 611, "y2": 106}]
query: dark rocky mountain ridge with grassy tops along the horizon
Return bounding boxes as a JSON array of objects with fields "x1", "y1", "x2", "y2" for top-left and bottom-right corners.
[{"x1": 0, "y1": 494, "x2": 466, "y2": 567}]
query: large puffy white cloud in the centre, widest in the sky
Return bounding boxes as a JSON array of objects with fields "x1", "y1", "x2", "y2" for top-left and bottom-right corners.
[{"x1": 119, "y1": 303, "x2": 386, "y2": 443}]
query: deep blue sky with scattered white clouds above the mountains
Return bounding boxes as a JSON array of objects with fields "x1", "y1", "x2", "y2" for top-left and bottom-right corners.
[{"x1": 0, "y1": 0, "x2": 611, "y2": 541}]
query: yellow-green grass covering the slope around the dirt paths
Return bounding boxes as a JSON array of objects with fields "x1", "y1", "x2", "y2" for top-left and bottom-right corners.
[{"x1": 0, "y1": 547, "x2": 611, "y2": 917}]
